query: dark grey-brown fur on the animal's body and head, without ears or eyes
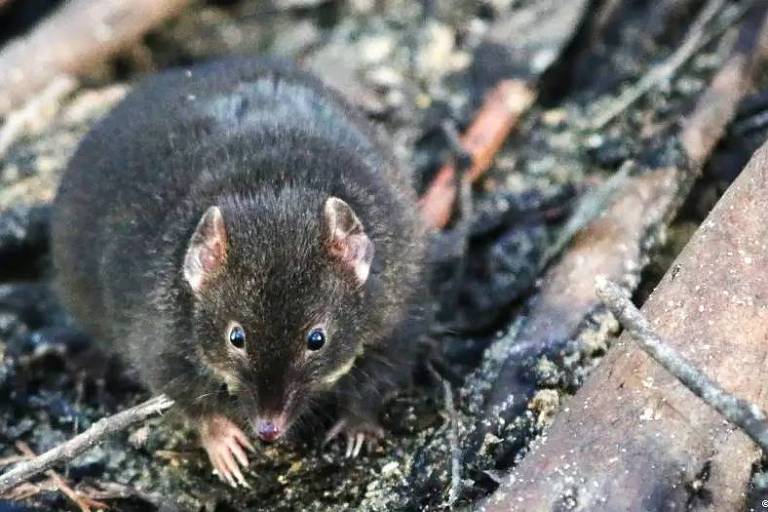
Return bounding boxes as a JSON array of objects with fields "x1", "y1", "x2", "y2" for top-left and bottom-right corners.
[{"x1": 53, "y1": 58, "x2": 424, "y2": 436}]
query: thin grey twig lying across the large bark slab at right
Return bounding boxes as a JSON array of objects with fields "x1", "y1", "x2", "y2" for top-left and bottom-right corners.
[{"x1": 596, "y1": 277, "x2": 768, "y2": 453}]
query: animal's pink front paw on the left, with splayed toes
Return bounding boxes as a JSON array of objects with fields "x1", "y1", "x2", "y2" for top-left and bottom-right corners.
[{"x1": 199, "y1": 415, "x2": 254, "y2": 487}]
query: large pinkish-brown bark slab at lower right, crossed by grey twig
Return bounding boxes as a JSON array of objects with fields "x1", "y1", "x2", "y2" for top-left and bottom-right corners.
[{"x1": 484, "y1": 138, "x2": 768, "y2": 511}]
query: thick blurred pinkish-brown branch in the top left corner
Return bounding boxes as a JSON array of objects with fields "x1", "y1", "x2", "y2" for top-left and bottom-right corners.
[{"x1": 0, "y1": 0, "x2": 189, "y2": 116}]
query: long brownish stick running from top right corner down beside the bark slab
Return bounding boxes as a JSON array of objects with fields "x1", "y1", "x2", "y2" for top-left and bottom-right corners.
[{"x1": 479, "y1": 3, "x2": 768, "y2": 435}]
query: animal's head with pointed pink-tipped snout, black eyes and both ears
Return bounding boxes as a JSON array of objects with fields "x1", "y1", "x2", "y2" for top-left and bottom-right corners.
[{"x1": 182, "y1": 194, "x2": 374, "y2": 441}]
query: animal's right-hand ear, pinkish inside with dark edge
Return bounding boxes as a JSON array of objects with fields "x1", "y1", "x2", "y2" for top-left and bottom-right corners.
[{"x1": 323, "y1": 197, "x2": 373, "y2": 285}]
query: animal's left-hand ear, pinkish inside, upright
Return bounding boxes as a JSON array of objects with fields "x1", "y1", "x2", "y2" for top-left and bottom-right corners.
[{"x1": 184, "y1": 206, "x2": 227, "y2": 293}]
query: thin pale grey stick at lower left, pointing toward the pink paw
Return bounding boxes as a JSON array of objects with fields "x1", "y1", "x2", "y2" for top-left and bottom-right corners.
[{"x1": 0, "y1": 395, "x2": 173, "y2": 495}]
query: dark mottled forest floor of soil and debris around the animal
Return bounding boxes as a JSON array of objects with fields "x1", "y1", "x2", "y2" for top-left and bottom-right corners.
[{"x1": 0, "y1": 0, "x2": 768, "y2": 511}]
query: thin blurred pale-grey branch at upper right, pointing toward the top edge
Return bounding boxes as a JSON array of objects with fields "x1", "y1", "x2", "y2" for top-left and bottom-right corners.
[{"x1": 591, "y1": 0, "x2": 745, "y2": 130}]
